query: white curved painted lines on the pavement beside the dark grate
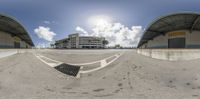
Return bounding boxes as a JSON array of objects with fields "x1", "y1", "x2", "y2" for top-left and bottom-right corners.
[{"x1": 34, "y1": 53, "x2": 123, "y2": 75}]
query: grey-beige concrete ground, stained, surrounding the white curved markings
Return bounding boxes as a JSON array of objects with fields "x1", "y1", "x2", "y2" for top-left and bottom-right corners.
[{"x1": 0, "y1": 49, "x2": 200, "y2": 99}]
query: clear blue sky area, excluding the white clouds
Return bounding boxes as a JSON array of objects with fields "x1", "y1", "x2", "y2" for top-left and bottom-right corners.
[{"x1": 0, "y1": 0, "x2": 200, "y2": 45}]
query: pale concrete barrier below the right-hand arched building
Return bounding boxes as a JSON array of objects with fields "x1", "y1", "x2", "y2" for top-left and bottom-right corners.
[{"x1": 137, "y1": 49, "x2": 200, "y2": 61}]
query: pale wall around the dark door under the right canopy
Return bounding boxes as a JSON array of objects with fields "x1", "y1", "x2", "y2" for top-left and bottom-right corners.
[{"x1": 144, "y1": 30, "x2": 200, "y2": 48}]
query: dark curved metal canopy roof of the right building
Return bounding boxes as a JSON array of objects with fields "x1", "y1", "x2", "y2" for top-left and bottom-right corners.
[{"x1": 138, "y1": 13, "x2": 200, "y2": 48}]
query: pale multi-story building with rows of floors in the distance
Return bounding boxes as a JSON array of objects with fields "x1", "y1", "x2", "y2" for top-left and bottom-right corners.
[{"x1": 55, "y1": 33, "x2": 108, "y2": 48}]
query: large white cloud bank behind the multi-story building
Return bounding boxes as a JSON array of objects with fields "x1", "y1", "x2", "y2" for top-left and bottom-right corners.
[{"x1": 76, "y1": 23, "x2": 142, "y2": 47}]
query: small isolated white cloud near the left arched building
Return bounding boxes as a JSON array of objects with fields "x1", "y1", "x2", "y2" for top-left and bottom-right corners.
[{"x1": 34, "y1": 26, "x2": 56, "y2": 41}]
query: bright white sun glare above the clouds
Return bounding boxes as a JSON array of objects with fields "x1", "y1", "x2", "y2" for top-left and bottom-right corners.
[{"x1": 88, "y1": 15, "x2": 111, "y2": 28}]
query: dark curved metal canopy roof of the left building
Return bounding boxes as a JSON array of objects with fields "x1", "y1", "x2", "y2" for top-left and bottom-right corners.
[{"x1": 0, "y1": 14, "x2": 34, "y2": 46}]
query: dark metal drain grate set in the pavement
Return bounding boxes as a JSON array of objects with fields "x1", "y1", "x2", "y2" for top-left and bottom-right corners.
[{"x1": 54, "y1": 63, "x2": 80, "y2": 76}]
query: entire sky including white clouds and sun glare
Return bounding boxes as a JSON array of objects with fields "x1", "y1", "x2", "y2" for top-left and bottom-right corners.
[{"x1": 0, "y1": 0, "x2": 200, "y2": 47}]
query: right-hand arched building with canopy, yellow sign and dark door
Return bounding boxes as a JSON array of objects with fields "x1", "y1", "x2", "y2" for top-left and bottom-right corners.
[{"x1": 138, "y1": 13, "x2": 200, "y2": 48}]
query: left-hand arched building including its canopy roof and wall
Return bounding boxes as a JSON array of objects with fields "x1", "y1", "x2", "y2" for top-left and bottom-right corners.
[{"x1": 0, "y1": 14, "x2": 34, "y2": 48}]
